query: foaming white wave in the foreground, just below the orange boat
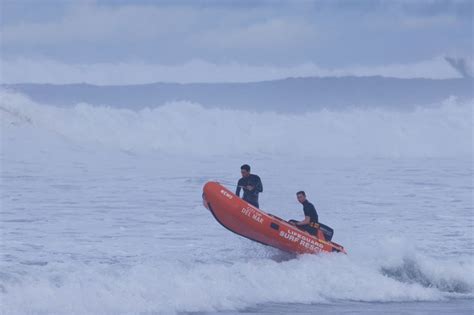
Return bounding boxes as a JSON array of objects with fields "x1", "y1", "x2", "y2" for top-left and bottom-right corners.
[{"x1": 0, "y1": 247, "x2": 474, "y2": 314}]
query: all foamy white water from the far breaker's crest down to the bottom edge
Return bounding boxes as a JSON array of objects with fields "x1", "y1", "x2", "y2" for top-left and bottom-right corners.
[{"x1": 0, "y1": 90, "x2": 474, "y2": 314}]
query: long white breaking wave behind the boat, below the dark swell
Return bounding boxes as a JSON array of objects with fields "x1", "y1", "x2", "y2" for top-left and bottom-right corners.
[{"x1": 0, "y1": 91, "x2": 474, "y2": 157}]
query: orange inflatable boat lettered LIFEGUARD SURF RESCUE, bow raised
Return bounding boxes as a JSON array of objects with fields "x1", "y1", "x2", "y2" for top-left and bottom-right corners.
[{"x1": 203, "y1": 182, "x2": 346, "y2": 254}]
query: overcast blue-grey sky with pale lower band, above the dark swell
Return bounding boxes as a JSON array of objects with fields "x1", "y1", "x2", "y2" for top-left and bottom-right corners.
[{"x1": 0, "y1": 0, "x2": 474, "y2": 84}]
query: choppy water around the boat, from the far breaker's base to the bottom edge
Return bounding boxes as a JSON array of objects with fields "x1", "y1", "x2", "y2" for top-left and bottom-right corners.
[{"x1": 0, "y1": 90, "x2": 474, "y2": 314}]
